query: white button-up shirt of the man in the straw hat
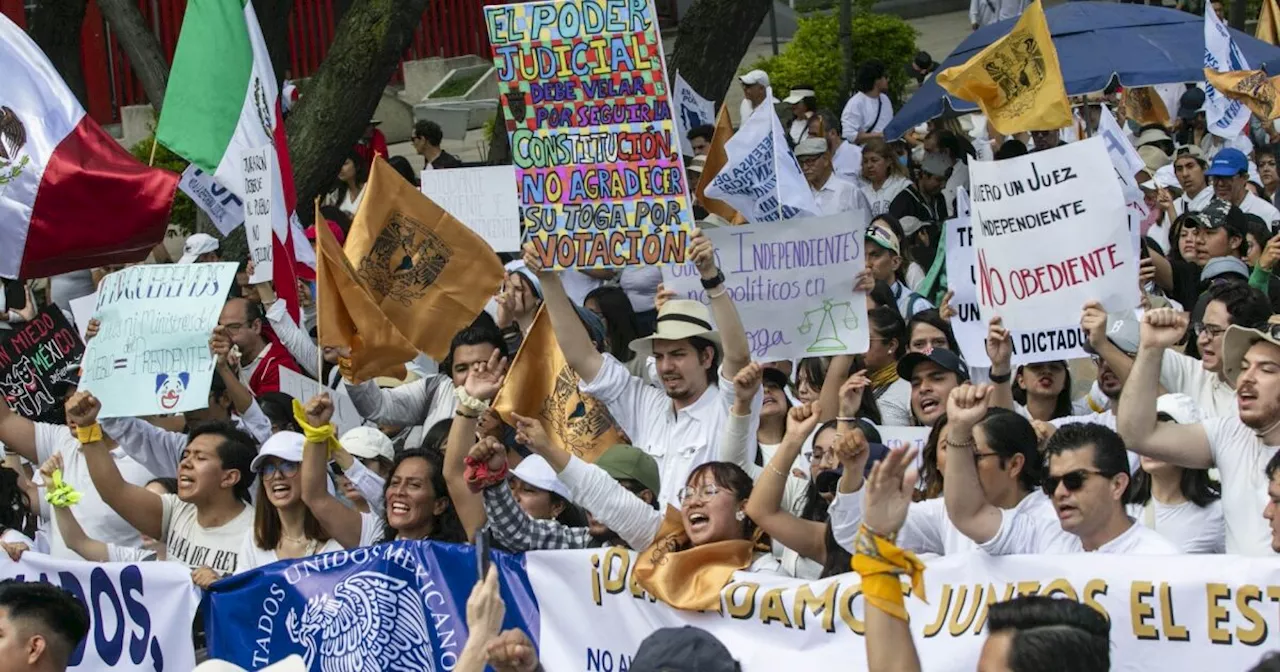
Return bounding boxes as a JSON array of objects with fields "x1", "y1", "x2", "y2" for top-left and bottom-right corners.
[{"x1": 579, "y1": 353, "x2": 764, "y2": 508}]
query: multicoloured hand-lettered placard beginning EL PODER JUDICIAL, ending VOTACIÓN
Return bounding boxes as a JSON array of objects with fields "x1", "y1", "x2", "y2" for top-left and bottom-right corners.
[{"x1": 484, "y1": 0, "x2": 694, "y2": 269}]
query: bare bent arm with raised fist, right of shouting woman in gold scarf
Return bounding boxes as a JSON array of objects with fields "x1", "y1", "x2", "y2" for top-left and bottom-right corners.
[{"x1": 746, "y1": 401, "x2": 827, "y2": 562}]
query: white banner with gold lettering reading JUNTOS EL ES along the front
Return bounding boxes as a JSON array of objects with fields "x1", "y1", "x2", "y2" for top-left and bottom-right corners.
[{"x1": 525, "y1": 548, "x2": 1280, "y2": 672}]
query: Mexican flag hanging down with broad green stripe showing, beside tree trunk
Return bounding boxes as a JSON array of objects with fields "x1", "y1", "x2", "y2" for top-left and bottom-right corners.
[{"x1": 156, "y1": 0, "x2": 316, "y2": 320}]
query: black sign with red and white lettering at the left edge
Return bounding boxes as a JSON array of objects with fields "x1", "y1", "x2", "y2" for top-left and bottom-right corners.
[{"x1": 0, "y1": 305, "x2": 84, "y2": 420}]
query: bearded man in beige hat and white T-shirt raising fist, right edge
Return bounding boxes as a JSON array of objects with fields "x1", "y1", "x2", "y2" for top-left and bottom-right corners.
[{"x1": 1117, "y1": 308, "x2": 1280, "y2": 556}]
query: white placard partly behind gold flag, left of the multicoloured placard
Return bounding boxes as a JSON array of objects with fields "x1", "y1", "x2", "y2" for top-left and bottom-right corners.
[{"x1": 422, "y1": 165, "x2": 520, "y2": 252}]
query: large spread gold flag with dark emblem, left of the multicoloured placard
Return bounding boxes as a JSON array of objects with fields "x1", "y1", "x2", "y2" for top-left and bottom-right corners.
[{"x1": 346, "y1": 156, "x2": 504, "y2": 361}]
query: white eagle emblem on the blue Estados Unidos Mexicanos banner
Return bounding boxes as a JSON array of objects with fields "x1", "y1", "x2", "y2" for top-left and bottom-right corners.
[{"x1": 284, "y1": 572, "x2": 435, "y2": 672}]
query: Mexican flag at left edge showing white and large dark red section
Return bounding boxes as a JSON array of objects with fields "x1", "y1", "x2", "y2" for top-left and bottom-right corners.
[{"x1": 0, "y1": 14, "x2": 178, "y2": 278}]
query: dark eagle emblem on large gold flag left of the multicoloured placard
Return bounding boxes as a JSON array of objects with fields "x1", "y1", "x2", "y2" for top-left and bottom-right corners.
[{"x1": 358, "y1": 212, "x2": 453, "y2": 306}]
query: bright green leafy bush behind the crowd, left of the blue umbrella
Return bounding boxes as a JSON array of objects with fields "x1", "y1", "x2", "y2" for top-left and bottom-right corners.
[{"x1": 751, "y1": 12, "x2": 916, "y2": 111}]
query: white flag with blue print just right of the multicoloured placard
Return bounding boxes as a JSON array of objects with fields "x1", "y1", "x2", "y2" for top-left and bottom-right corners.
[{"x1": 704, "y1": 90, "x2": 819, "y2": 221}]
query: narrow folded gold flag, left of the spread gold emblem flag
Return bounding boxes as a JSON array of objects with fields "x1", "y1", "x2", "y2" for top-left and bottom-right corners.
[{"x1": 316, "y1": 204, "x2": 417, "y2": 383}]
